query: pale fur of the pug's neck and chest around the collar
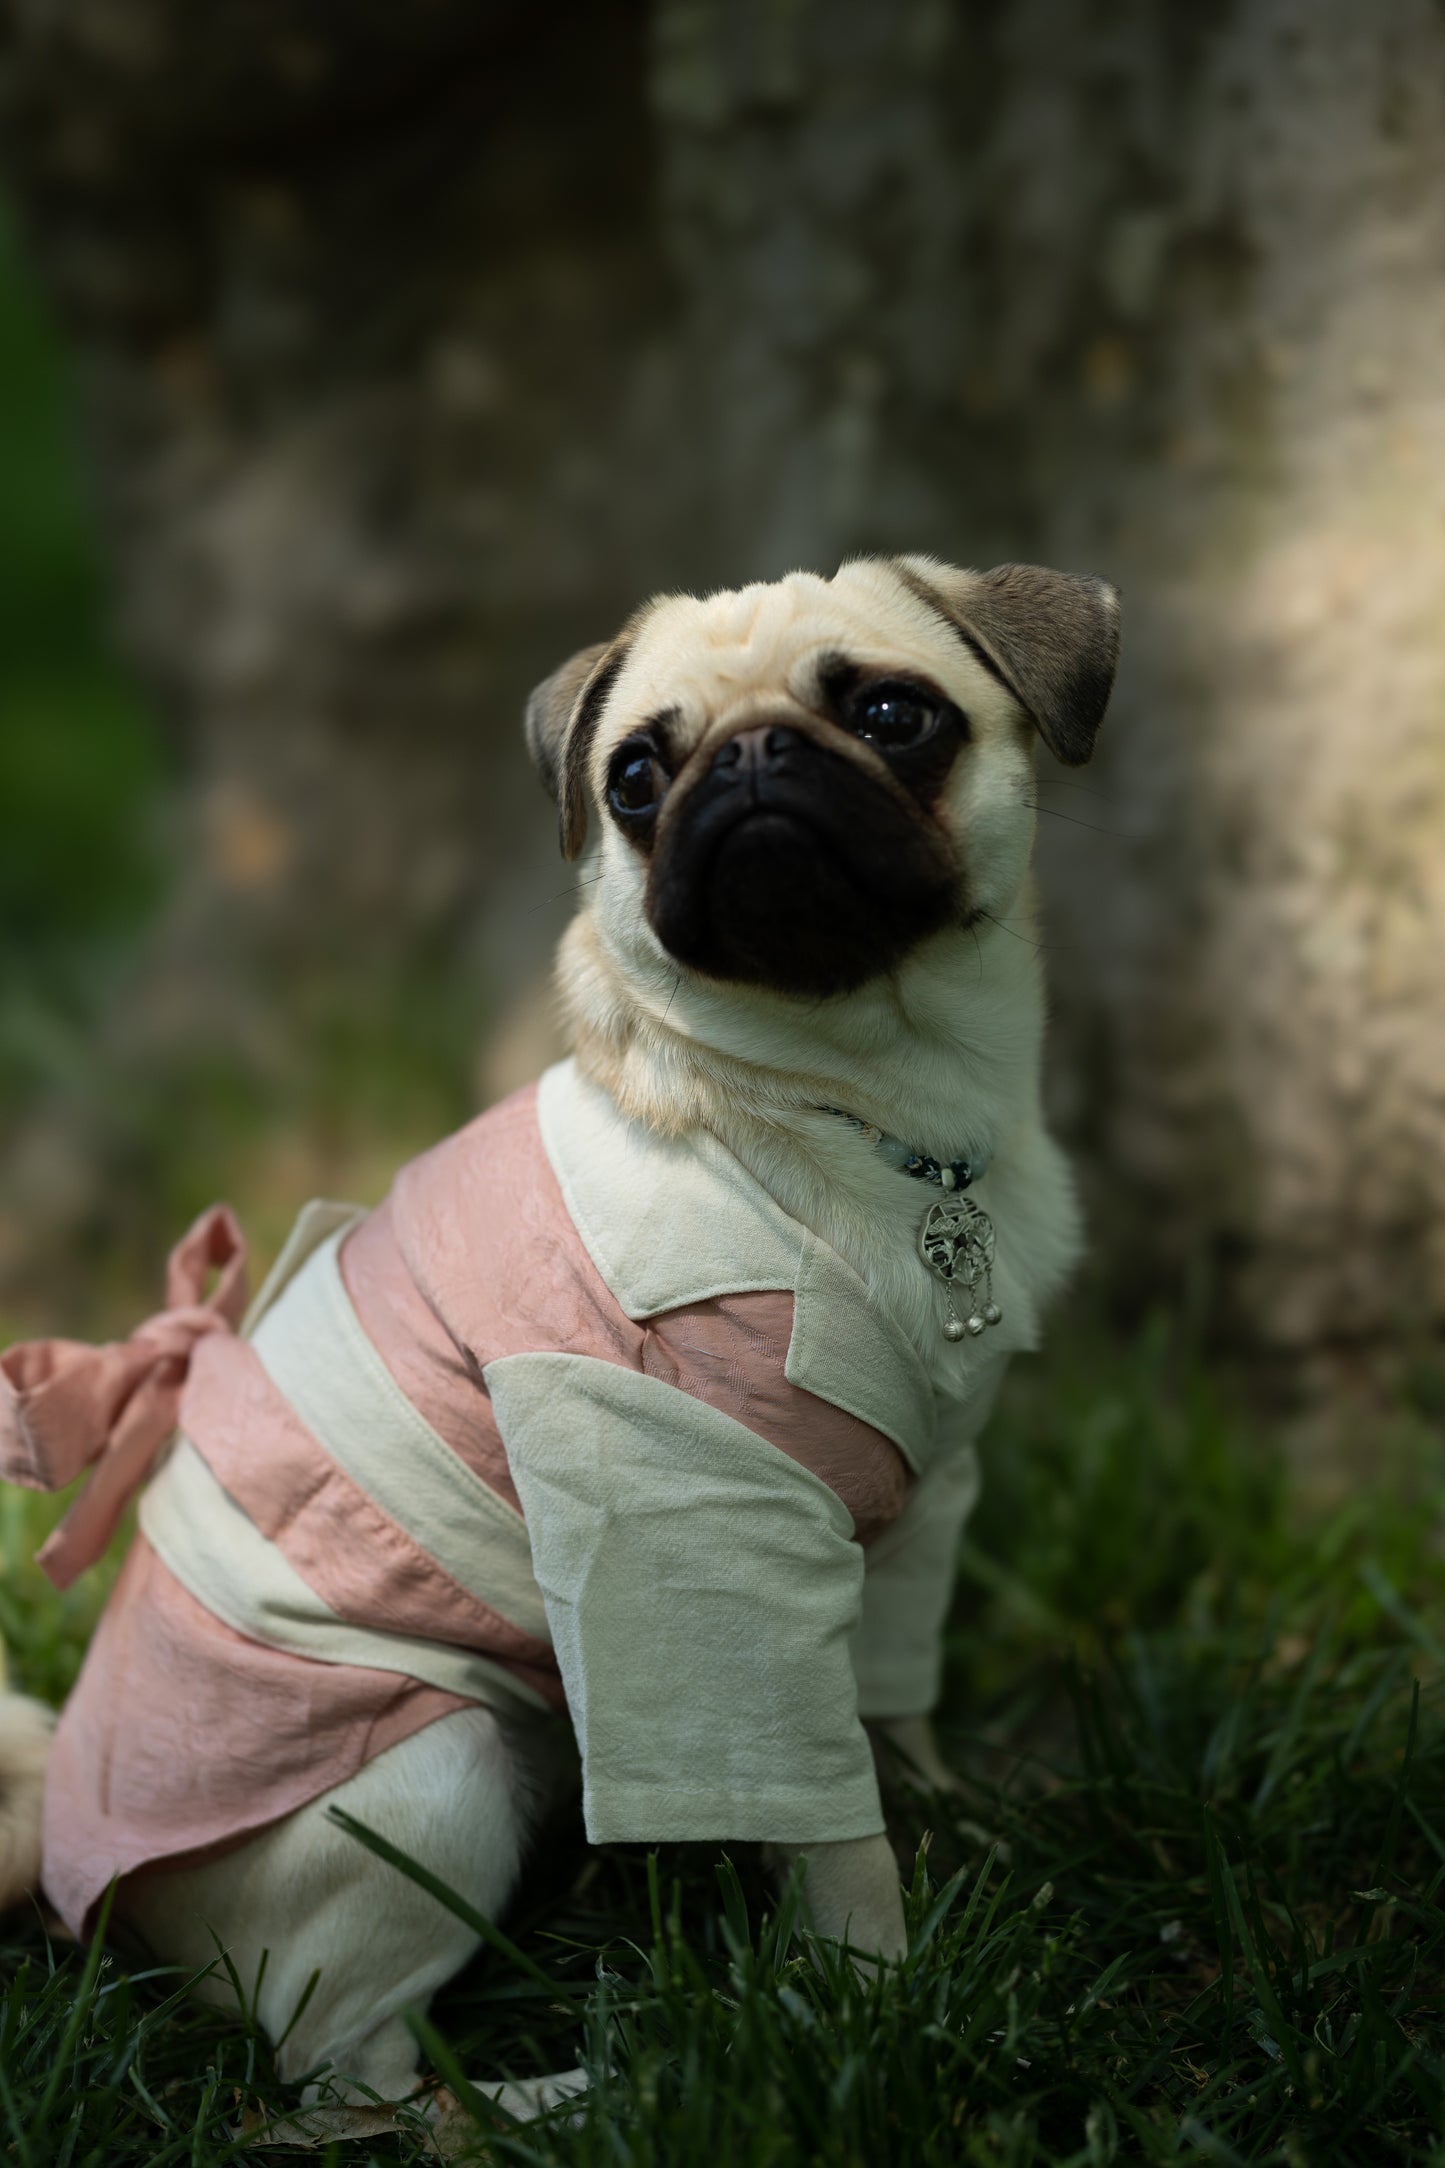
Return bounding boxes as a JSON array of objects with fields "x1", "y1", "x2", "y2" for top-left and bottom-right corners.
[{"x1": 559, "y1": 880, "x2": 1081, "y2": 1392}]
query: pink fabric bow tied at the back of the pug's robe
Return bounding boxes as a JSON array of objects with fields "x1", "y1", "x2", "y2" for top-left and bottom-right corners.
[{"x1": 0, "y1": 1205, "x2": 247, "y2": 1589}]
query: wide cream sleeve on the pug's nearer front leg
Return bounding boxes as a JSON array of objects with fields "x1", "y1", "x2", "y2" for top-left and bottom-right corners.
[{"x1": 485, "y1": 1355, "x2": 884, "y2": 1845}]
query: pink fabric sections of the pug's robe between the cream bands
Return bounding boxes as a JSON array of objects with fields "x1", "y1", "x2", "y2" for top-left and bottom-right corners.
[{"x1": 6, "y1": 1088, "x2": 910, "y2": 1932}]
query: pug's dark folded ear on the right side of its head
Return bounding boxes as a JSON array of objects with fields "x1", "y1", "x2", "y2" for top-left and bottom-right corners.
[{"x1": 897, "y1": 557, "x2": 1118, "y2": 767}]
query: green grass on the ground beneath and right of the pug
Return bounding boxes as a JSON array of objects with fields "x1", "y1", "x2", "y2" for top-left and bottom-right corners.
[{"x1": 0, "y1": 1327, "x2": 1445, "y2": 2168}]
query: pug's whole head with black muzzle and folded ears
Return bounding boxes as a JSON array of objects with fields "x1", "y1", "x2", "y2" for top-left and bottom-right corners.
[{"x1": 526, "y1": 557, "x2": 1118, "y2": 999}]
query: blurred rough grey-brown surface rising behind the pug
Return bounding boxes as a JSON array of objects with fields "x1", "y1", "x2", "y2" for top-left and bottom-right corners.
[{"x1": 4, "y1": 0, "x2": 1445, "y2": 1348}]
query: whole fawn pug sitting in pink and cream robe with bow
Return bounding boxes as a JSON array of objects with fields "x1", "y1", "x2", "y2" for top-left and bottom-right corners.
[{"x1": 0, "y1": 557, "x2": 1118, "y2": 2114}]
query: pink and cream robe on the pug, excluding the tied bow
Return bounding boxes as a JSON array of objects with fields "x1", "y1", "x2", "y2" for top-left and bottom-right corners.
[{"x1": 43, "y1": 1062, "x2": 996, "y2": 1930}]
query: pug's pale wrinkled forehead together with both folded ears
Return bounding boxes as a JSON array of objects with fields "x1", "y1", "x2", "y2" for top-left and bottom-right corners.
[{"x1": 526, "y1": 557, "x2": 1118, "y2": 859}]
